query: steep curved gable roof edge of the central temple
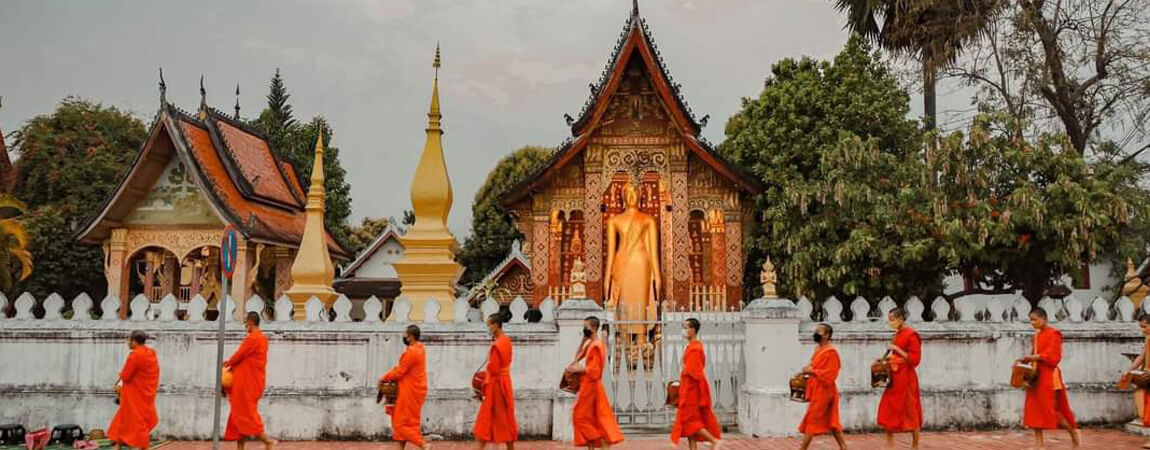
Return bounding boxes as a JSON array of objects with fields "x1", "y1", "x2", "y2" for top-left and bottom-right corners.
[{"x1": 500, "y1": 0, "x2": 762, "y2": 205}]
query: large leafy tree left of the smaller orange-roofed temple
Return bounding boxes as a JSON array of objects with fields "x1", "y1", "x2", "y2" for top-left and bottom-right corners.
[{"x1": 13, "y1": 97, "x2": 147, "y2": 298}]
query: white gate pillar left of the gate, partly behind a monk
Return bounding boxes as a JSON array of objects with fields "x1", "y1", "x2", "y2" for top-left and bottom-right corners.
[{"x1": 550, "y1": 298, "x2": 606, "y2": 441}]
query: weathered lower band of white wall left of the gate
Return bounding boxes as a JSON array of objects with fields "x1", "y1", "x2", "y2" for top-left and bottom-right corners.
[{"x1": 0, "y1": 390, "x2": 556, "y2": 441}]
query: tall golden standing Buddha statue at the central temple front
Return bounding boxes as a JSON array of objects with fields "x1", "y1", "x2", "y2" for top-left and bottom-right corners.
[{"x1": 603, "y1": 183, "x2": 662, "y2": 346}]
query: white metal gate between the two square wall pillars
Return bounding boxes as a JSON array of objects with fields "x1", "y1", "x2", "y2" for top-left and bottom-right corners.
[{"x1": 604, "y1": 311, "x2": 745, "y2": 433}]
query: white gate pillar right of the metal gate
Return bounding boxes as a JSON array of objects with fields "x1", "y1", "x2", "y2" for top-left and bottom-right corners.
[{"x1": 738, "y1": 298, "x2": 807, "y2": 436}]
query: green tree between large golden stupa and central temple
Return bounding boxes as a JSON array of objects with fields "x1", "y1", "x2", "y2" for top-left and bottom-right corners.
[{"x1": 455, "y1": 146, "x2": 552, "y2": 285}]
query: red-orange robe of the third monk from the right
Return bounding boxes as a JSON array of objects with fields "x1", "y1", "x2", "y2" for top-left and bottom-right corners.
[{"x1": 879, "y1": 327, "x2": 922, "y2": 433}]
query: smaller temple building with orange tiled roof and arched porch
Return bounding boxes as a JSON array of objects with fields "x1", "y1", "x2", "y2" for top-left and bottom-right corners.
[{"x1": 77, "y1": 84, "x2": 350, "y2": 317}]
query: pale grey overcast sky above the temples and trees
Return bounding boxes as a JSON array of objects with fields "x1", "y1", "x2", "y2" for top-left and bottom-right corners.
[{"x1": 0, "y1": 0, "x2": 968, "y2": 238}]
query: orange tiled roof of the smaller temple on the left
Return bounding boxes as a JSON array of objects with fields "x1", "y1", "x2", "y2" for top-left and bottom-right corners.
[{"x1": 77, "y1": 94, "x2": 350, "y2": 260}]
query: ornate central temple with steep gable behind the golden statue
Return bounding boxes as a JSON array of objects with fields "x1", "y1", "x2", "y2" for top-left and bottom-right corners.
[{"x1": 501, "y1": 5, "x2": 762, "y2": 316}]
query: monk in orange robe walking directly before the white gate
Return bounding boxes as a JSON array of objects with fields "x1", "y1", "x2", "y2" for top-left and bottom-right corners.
[{"x1": 670, "y1": 318, "x2": 722, "y2": 450}]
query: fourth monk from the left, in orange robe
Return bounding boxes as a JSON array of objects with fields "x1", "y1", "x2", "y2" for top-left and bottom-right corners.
[{"x1": 475, "y1": 313, "x2": 519, "y2": 450}]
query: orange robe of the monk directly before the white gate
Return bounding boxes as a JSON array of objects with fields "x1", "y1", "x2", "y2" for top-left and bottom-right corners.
[{"x1": 670, "y1": 340, "x2": 720, "y2": 445}]
